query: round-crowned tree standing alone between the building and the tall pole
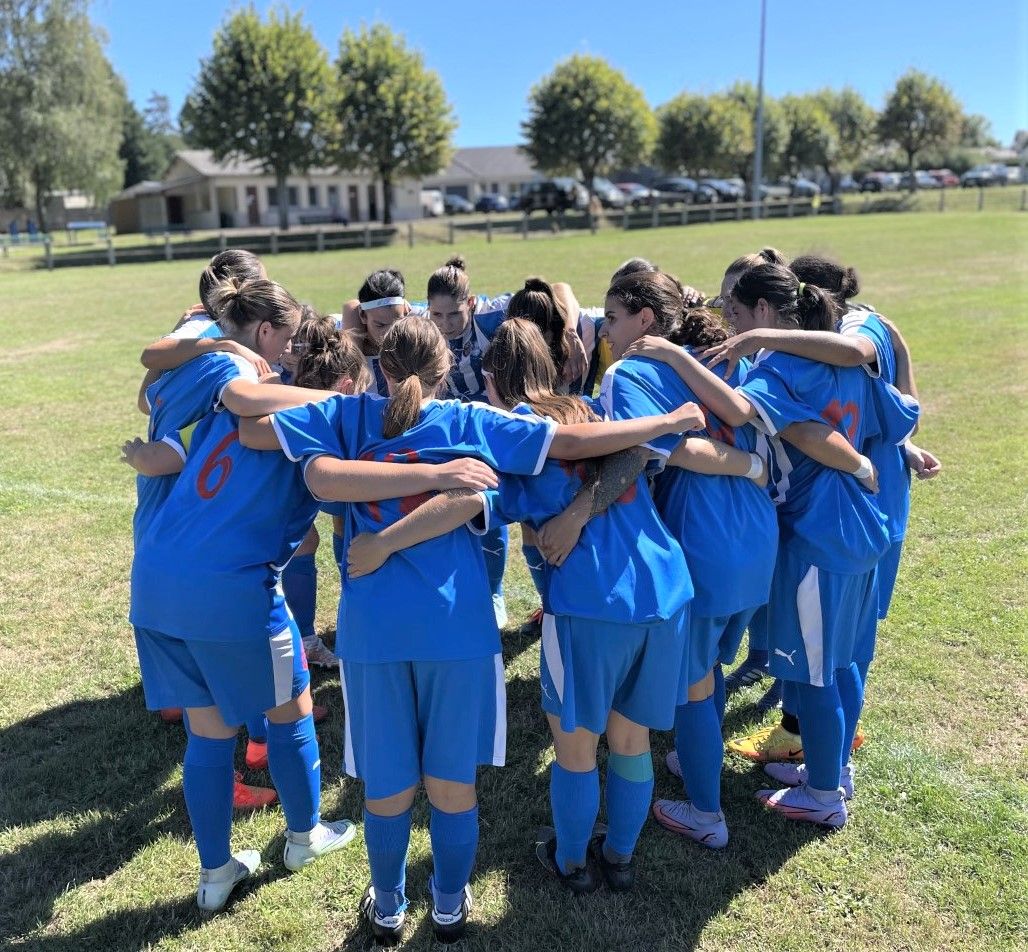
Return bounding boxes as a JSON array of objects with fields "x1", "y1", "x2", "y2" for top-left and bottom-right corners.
[{"x1": 521, "y1": 56, "x2": 656, "y2": 215}]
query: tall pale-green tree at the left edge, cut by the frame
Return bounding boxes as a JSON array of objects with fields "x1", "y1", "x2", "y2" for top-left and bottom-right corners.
[{"x1": 0, "y1": 0, "x2": 122, "y2": 230}]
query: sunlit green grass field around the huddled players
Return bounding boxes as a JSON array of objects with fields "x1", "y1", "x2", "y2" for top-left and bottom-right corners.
[{"x1": 0, "y1": 212, "x2": 1028, "y2": 952}]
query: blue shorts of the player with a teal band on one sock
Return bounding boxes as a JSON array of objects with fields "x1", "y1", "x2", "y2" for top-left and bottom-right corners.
[{"x1": 540, "y1": 606, "x2": 689, "y2": 734}]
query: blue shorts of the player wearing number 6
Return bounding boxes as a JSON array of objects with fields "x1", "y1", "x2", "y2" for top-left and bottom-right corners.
[{"x1": 136, "y1": 618, "x2": 310, "y2": 727}]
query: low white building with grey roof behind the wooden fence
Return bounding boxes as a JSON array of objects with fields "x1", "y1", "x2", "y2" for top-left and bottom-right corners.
[{"x1": 111, "y1": 149, "x2": 421, "y2": 231}]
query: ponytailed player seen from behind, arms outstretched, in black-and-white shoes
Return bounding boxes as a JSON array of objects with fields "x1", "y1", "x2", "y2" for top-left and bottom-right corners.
[{"x1": 243, "y1": 317, "x2": 697, "y2": 942}]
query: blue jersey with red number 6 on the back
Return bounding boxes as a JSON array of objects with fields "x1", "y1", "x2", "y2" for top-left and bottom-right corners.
[{"x1": 131, "y1": 411, "x2": 318, "y2": 642}]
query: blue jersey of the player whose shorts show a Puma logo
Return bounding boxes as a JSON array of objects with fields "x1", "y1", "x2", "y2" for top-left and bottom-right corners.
[{"x1": 738, "y1": 352, "x2": 917, "y2": 575}]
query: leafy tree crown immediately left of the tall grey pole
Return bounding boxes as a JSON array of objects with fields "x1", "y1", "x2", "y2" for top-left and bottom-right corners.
[{"x1": 655, "y1": 93, "x2": 754, "y2": 176}]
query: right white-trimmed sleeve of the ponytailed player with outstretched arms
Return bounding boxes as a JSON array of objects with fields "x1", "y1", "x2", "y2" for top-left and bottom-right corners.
[{"x1": 460, "y1": 403, "x2": 557, "y2": 475}]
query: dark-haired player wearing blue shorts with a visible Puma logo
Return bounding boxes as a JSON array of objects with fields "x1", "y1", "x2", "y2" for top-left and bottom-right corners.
[{"x1": 620, "y1": 264, "x2": 917, "y2": 827}]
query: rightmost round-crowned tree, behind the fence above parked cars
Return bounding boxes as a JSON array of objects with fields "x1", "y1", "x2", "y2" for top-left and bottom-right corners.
[{"x1": 878, "y1": 70, "x2": 961, "y2": 191}]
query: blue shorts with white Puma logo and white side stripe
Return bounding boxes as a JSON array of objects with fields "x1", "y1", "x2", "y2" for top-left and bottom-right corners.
[{"x1": 768, "y1": 547, "x2": 878, "y2": 688}]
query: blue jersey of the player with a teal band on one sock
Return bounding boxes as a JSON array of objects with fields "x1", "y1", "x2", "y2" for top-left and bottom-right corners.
[{"x1": 483, "y1": 408, "x2": 693, "y2": 625}]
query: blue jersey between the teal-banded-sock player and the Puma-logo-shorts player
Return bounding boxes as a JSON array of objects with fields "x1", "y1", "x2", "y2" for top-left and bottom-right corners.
[{"x1": 600, "y1": 357, "x2": 778, "y2": 618}]
